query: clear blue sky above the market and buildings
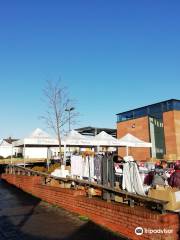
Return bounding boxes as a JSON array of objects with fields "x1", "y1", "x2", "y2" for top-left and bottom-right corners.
[{"x1": 0, "y1": 0, "x2": 180, "y2": 137}]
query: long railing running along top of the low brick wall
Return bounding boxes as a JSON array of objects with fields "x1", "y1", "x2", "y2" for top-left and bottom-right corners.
[{"x1": 5, "y1": 165, "x2": 168, "y2": 213}]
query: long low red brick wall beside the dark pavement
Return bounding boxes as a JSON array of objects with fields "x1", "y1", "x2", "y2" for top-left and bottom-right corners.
[{"x1": 1, "y1": 174, "x2": 180, "y2": 240}]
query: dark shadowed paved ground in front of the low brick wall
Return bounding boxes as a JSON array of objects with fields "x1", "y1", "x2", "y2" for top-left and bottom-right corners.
[{"x1": 0, "y1": 180, "x2": 127, "y2": 240}]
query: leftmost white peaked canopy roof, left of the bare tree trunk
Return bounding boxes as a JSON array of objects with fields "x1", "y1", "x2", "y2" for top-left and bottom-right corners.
[{"x1": 13, "y1": 128, "x2": 59, "y2": 147}]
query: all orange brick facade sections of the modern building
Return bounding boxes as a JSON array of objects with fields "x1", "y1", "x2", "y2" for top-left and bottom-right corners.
[{"x1": 117, "y1": 111, "x2": 180, "y2": 160}]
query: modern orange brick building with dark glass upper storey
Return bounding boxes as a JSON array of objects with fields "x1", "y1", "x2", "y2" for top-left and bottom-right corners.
[{"x1": 117, "y1": 99, "x2": 180, "y2": 160}]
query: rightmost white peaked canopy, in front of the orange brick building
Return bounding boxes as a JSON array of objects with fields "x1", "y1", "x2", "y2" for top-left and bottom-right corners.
[{"x1": 118, "y1": 133, "x2": 152, "y2": 147}]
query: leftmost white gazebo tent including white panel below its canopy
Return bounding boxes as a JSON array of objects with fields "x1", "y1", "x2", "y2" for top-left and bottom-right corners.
[{"x1": 13, "y1": 128, "x2": 59, "y2": 161}]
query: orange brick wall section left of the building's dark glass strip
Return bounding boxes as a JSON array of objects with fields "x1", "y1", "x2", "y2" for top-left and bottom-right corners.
[{"x1": 117, "y1": 116, "x2": 151, "y2": 160}]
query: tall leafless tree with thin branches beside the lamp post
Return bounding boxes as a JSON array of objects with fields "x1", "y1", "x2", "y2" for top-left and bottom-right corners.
[{"x1": 41, "y1": 80, "x2": 78, "y2": 160}]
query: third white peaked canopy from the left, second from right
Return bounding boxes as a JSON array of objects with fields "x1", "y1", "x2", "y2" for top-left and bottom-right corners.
[{"x1": 94, "y1": 131, "x2": 120, "y2": 146}]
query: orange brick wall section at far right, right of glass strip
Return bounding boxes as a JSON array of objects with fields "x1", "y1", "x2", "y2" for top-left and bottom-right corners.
[{"x1": 163, "y1": 111, "x2": 180, "y2": 160}]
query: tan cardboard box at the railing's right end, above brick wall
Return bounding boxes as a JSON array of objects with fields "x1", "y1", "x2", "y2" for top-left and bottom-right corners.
[{"x1": 148, "y1": 186, "x2": 180, "y2": 211}]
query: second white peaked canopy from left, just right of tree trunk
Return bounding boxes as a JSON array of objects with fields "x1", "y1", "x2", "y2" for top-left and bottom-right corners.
[{"x1": 63, "y1": 130, "x2": 94, "y2": 146}]
